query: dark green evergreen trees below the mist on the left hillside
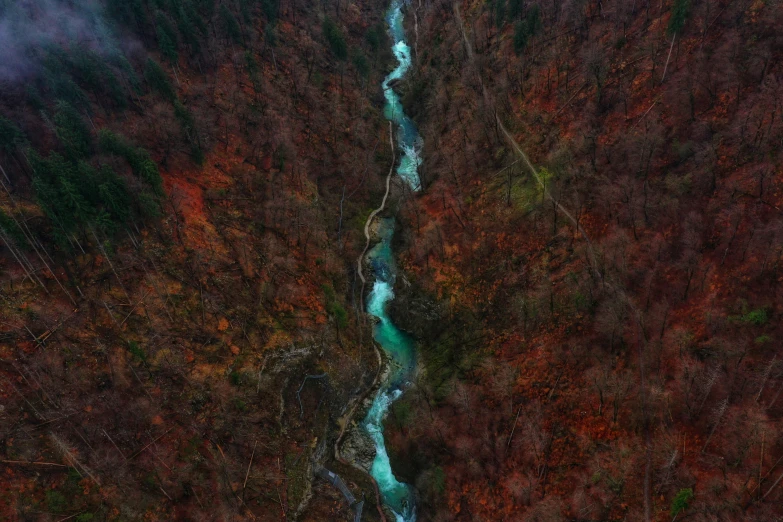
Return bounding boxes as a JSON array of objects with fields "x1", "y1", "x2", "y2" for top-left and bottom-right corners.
[{"x1": 0, "y1": 0, "x2": 378, "y2": 246}]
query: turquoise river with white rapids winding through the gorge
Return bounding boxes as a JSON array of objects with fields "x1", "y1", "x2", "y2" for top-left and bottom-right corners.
[{"x1": 364, "y1": 0, "x2": 422, "y2": 522}]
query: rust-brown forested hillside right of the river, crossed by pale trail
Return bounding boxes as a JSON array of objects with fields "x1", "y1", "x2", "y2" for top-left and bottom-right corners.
[{"x1": 387, "y1": 0, "x2": 783, "y2": 521}]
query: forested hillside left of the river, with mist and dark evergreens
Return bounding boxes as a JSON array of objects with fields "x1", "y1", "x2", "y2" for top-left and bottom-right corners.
[{"x1": 0, "y1": 0, "x2": 398, "y2": 522}]
